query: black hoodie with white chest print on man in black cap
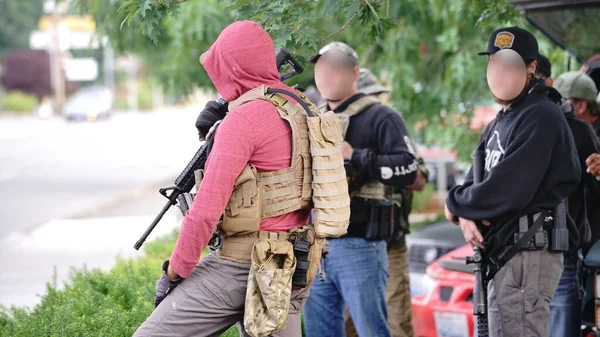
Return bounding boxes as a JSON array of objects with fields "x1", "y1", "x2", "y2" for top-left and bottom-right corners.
[{"x1": 446, "y1": 80, "x2": 581, "y2": 255}]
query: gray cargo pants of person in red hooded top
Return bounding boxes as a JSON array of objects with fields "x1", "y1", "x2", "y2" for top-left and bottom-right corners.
[{"x1": 133, "y1": 253, "x2": 309, "y2": 337}]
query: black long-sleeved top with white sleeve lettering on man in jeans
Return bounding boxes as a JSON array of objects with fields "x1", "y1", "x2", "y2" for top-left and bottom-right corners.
[{"x1": 334, "y1": 94, "x2": 418, "y2": 237}]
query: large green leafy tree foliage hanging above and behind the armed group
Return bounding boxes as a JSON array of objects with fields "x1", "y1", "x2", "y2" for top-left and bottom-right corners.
[{"x1": 79, "y1": 0, "x2": 558, "y2": 159}]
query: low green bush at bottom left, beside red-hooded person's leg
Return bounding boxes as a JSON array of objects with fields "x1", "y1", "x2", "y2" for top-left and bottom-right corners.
[{"x1": 0, "y1": 232, "x2": 238, "y2": 337}]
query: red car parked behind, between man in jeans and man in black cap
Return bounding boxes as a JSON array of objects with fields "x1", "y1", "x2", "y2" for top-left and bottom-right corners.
[{"x1": 412, "y1": 245, "x2": 475, "y2": 337}]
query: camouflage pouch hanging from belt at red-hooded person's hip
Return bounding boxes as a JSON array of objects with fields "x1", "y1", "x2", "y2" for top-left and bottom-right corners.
[{"x1": 244, "y1": 239, "x2": 296, "y2": 337}]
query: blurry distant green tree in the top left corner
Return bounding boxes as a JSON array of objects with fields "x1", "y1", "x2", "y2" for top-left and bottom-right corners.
[{"x1": 0, "y1": 0, "x2": 44, "y2": 59}]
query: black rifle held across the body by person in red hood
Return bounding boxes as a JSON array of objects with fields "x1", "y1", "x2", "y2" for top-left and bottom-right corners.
[{"x1": 133, "y1": 48, "x2": 304, "y2": 250}]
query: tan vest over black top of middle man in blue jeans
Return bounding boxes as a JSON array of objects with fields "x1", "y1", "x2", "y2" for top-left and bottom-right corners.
[{"x1": 338, "y1": 95, "x2": 393, "y2": 200}]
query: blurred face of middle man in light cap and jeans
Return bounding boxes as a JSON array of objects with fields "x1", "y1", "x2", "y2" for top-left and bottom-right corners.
[{"x1": 315, "y1": 53, "x2": 360, "y2": 102}]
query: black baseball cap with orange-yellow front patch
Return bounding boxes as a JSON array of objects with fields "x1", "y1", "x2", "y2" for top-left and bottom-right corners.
[{"x1": 479, "y1": 27, "x2": 540, "y2": 62}]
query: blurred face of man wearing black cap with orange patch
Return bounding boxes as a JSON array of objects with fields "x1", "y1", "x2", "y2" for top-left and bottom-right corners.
[{"x1": 487, "y1": 49, "x2": 537, "y2": 105}]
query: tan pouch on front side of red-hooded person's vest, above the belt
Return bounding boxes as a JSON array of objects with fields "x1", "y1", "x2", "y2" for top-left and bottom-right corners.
[{"x1": 220, "y1": 165, "x2": 261, "y2": 236}]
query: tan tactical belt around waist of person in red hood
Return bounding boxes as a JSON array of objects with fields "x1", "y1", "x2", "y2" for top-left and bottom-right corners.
[{"x1": 211, "y1": 229, "x2": 295, "y2": 264}]
